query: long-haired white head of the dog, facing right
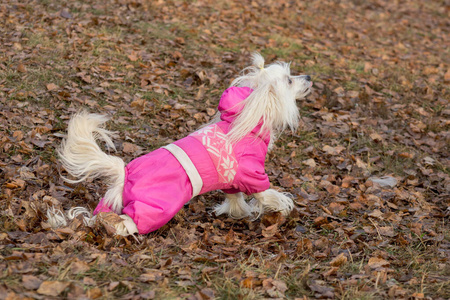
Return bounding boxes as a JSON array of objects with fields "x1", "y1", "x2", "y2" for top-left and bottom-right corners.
[{"x1": 229, "y1": 53, "x2": 312, "y2": 141}]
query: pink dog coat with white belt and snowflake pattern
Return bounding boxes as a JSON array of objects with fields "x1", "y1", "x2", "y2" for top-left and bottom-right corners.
[{"x1": 94, "y1": 87, "x2": 270, "y2": 234}]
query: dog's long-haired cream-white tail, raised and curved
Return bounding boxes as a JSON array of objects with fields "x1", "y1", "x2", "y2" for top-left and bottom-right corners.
[{"x1": 58, "y1": 111, "x2": 125, "y2": 213}]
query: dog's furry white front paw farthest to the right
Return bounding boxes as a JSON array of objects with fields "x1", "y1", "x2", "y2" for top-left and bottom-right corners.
[{"x1": 251, "y1": 189, "x2": 294, "y2": 218}]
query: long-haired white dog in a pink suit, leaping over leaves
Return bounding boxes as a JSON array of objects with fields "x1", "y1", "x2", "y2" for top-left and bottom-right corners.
[{"x1": 49, "y1": 53, "x2": 313, "y2": 236}]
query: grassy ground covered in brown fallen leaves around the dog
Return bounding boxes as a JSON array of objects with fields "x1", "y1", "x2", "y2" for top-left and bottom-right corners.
[{"x1": 0, "y1": 0, "x2": 450, "y2": 299}]
